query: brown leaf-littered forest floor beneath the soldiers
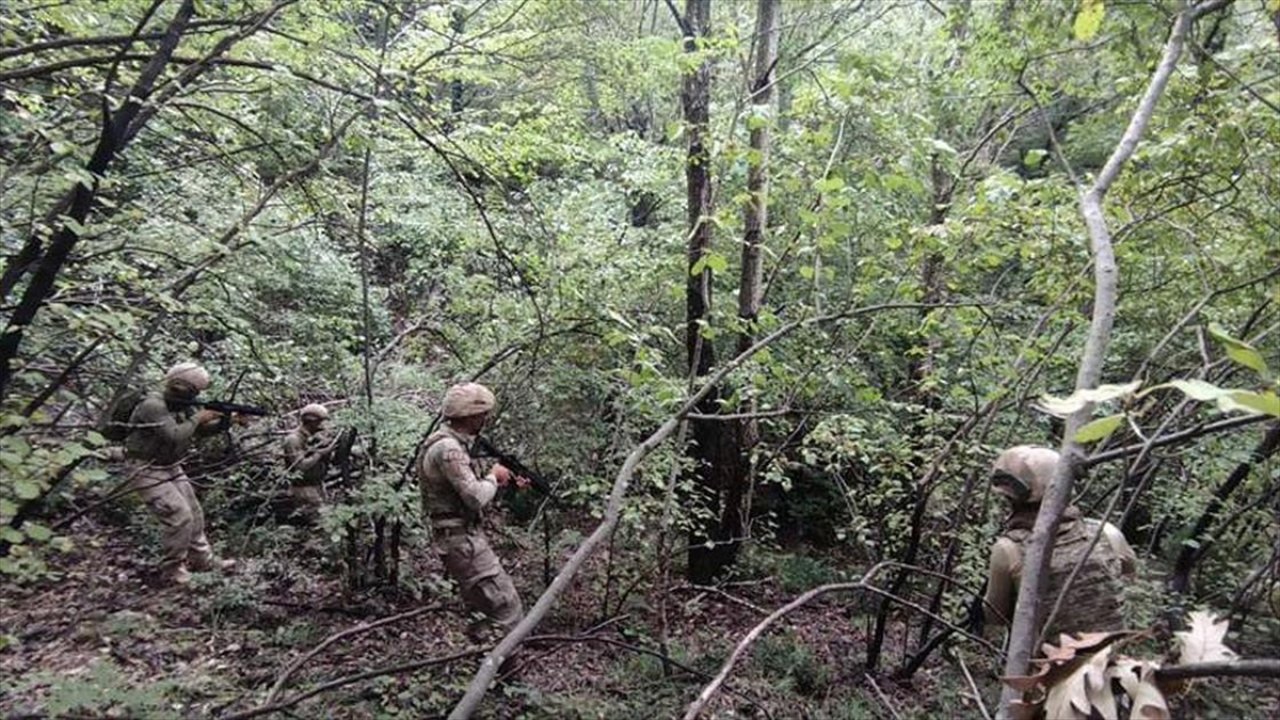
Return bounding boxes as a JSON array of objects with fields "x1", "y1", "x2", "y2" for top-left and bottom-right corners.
[{"x1": 0, "y1": 507, "x2": 1280, "y2": 720}]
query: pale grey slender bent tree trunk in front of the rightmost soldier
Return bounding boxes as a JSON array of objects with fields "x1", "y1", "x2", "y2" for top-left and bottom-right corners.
[{"x1": 1000, "y1": 3, "x2": 1222, "y2": 717}]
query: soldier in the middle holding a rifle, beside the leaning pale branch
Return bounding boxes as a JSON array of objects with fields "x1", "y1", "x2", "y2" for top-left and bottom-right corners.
[{"x1": 416, "y1": 383, "x2": 525, "y2": 637}]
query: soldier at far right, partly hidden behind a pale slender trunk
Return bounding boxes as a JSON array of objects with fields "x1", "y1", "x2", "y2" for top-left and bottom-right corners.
[{"x1": 986, "y1": 445, "x2": 1138, "y2": 638}]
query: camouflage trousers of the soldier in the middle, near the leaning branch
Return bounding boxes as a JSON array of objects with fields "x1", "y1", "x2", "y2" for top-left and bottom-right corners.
[{"x1": 436, "y1": 528, "x2": 525, "y2": 639}]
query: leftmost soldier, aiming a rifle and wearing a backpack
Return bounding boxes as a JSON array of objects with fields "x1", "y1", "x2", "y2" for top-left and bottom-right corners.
[{"x1": 124, "y1": 363, "x2": 236, "y2": 585}]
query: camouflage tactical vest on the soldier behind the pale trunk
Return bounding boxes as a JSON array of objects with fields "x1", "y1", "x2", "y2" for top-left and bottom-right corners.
[{"x1": 1005, "y1": 520, "x2": 1124, "y2": 635}]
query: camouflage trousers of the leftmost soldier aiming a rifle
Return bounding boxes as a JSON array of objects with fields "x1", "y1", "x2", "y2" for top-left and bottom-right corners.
[{"x1": 127, "y1": 460, "x2": 214, "y2": 577}]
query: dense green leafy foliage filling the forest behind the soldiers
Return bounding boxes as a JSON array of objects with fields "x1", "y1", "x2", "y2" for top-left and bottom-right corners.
[{"x1": 0, "y1": 0, "x2": 1280, "y2": 717}]
